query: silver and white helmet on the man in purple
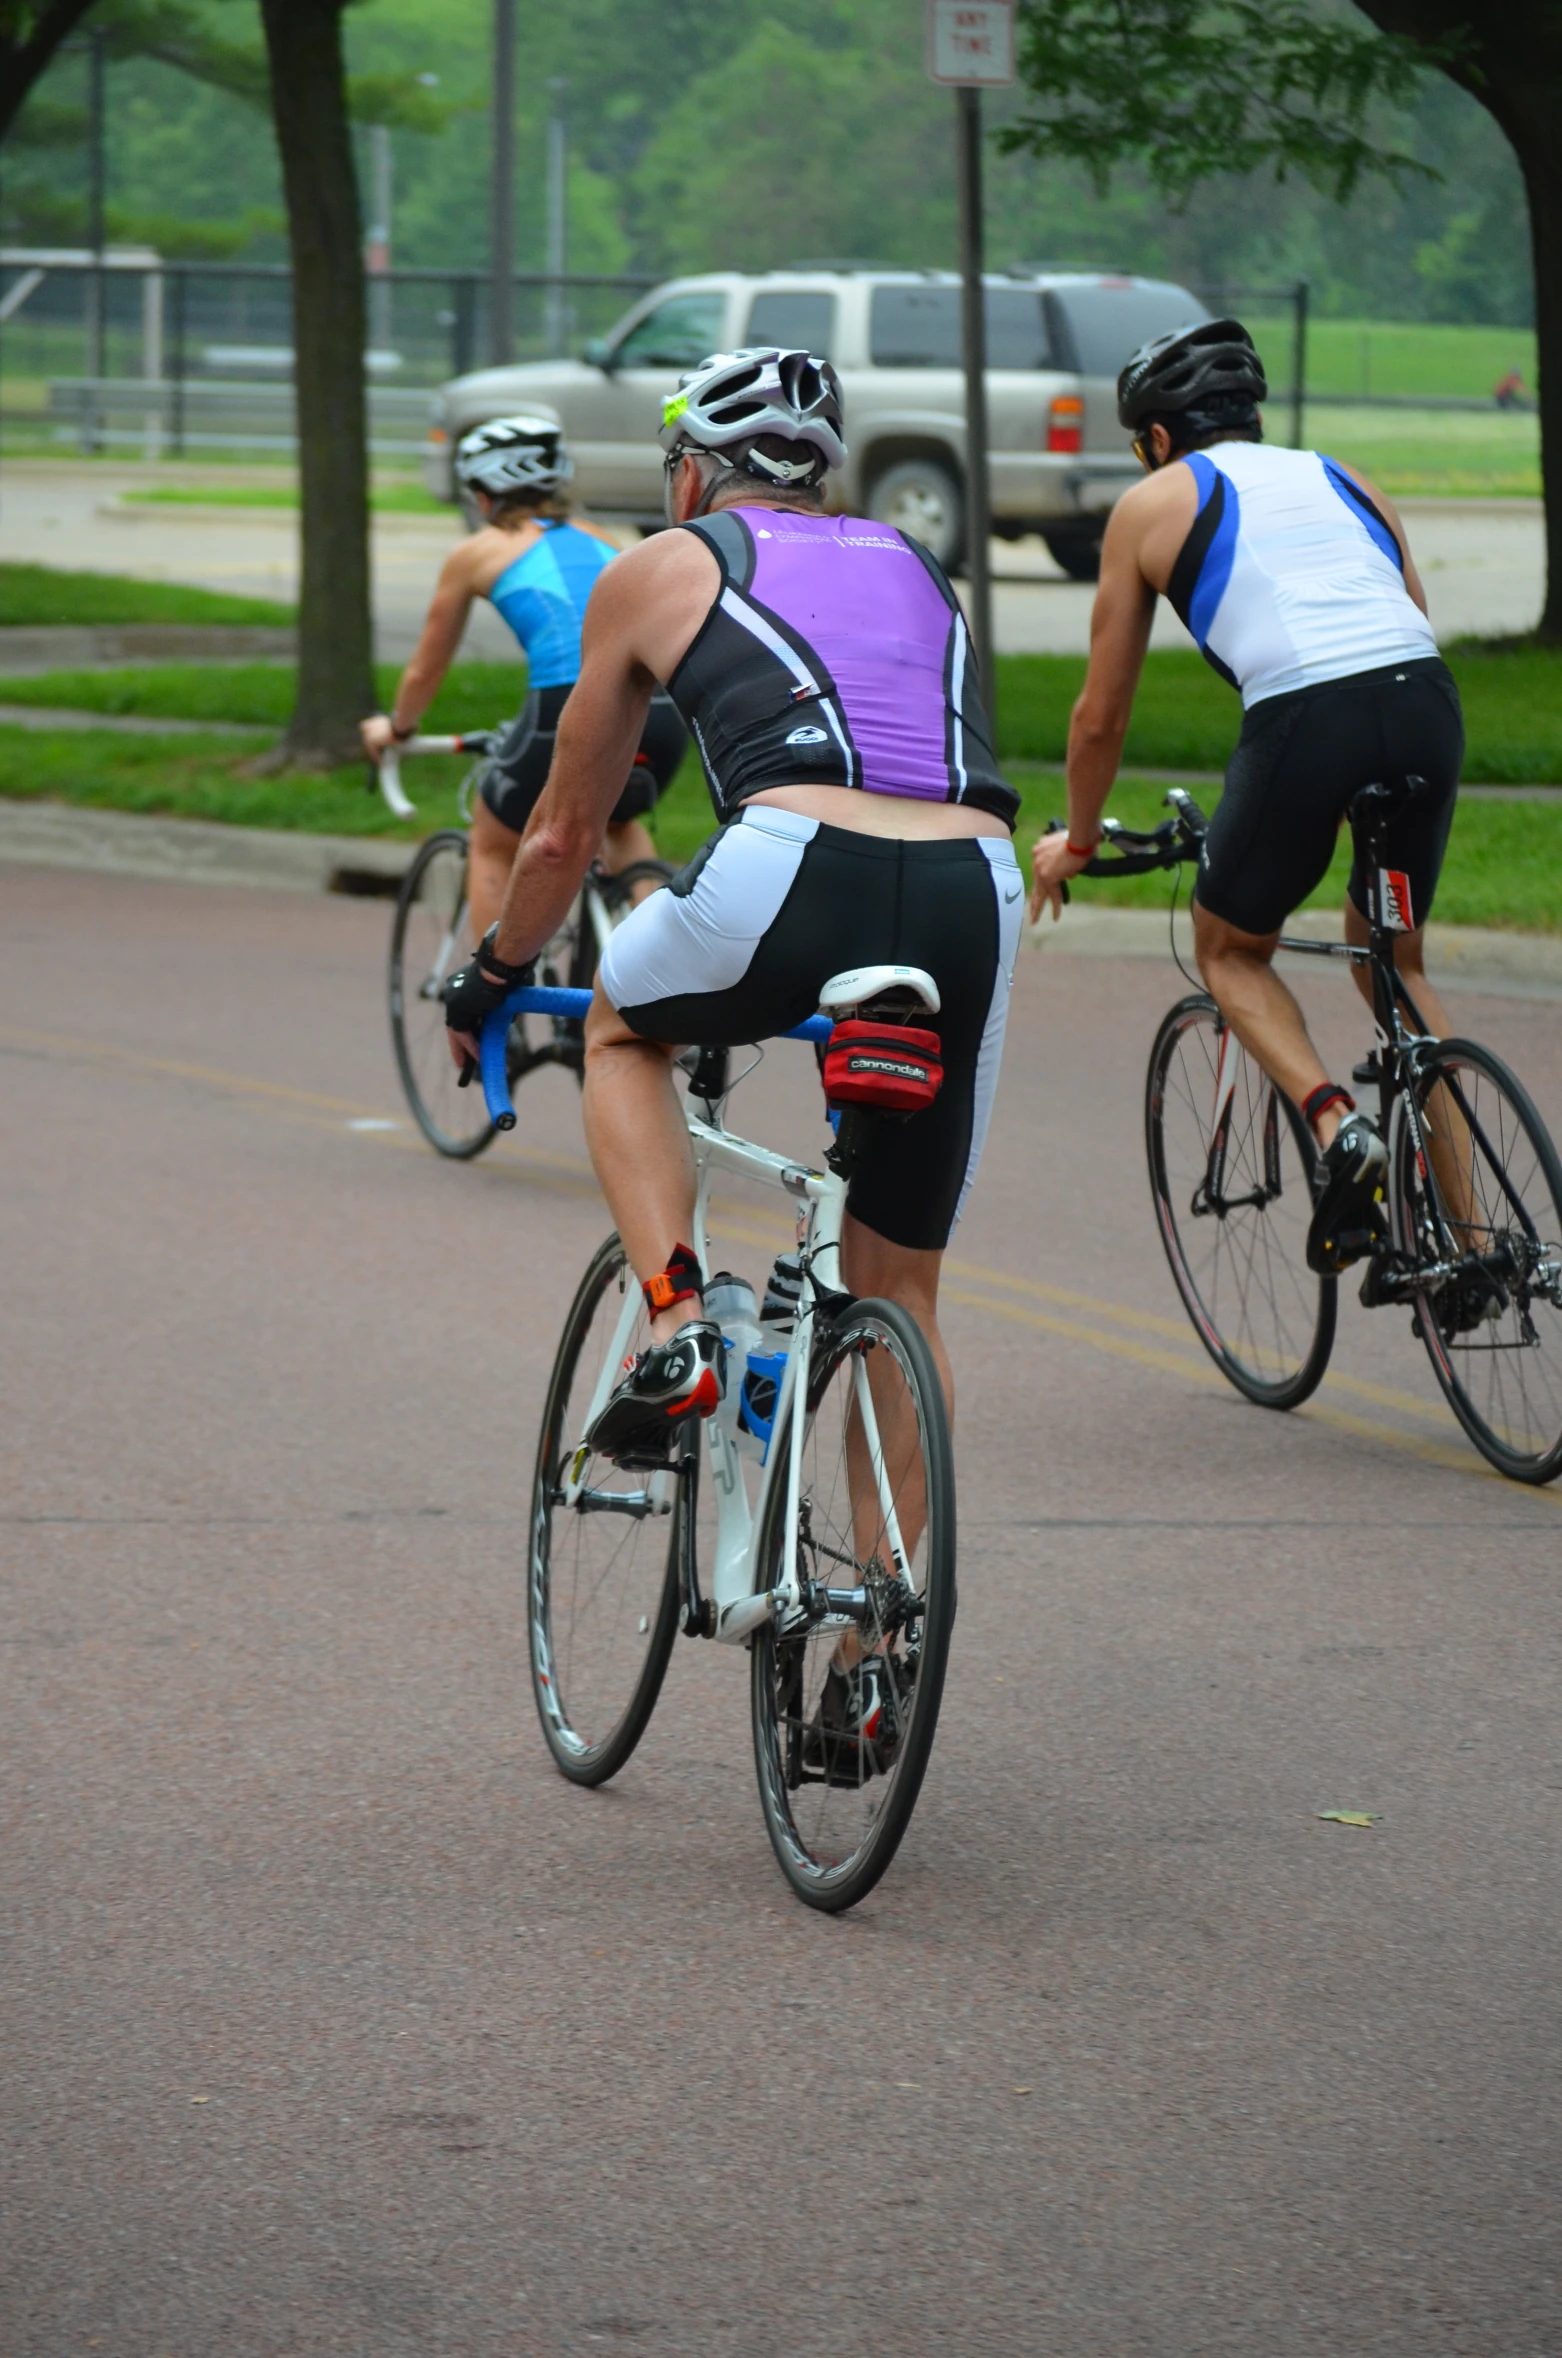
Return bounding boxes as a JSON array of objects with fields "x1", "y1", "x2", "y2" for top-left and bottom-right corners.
[{"x1": 661, "y1": 344, "x2": 847, "y2": 488}]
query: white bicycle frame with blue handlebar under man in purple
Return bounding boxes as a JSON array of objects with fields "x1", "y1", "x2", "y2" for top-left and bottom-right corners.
[{"x1": 479, "y1": 986, "x2": 908, "y2": 1646}]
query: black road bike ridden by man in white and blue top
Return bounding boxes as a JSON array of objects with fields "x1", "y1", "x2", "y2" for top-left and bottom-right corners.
[{"x1": 1085, "y1": 778, "x2": 1562, "y2": 1483}]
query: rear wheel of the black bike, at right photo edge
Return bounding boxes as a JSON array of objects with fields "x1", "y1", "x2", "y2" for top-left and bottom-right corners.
[{"x1": 1390, "y1": 1040, "x2": 1562, "y2": 1483}]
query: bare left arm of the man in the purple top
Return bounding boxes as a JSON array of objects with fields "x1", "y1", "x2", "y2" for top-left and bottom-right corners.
[{"x1": 493, "y1": 533, "x2": 720, "y2": 967}]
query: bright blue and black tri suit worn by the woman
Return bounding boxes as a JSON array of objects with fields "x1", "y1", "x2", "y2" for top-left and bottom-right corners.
[{"x1": 481, "y1": 519, "x2": 689, "y2": 835}]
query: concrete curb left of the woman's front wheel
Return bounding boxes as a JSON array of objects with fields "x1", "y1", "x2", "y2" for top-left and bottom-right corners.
[{"x1": 0, "y1": 802, "x2": 418, "y2": 898}]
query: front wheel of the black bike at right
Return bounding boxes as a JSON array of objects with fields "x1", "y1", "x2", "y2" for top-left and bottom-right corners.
[{"x1": 1144, "y1": 990, "x2": 1338, "y2": 1408}]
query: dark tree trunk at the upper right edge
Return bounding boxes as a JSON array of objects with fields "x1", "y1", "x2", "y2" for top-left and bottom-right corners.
[{"x1": 1357, "y1": 0, "x2": 1562, "y2": 646}]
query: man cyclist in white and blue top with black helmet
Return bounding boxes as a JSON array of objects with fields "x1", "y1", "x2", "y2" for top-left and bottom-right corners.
[{"x1": 1031, "y1": 318, "x2": 1465, "y2": 1273}]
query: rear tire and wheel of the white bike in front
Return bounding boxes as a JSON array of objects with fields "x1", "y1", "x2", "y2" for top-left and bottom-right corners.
[{"x1": 750, "y1": 1302, "x2": 956, "y2": 1915}]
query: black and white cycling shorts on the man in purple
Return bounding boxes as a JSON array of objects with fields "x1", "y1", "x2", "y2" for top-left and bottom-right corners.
[{"x1": 602, "y1": 804, "x2": 1024, "y2": 1252}]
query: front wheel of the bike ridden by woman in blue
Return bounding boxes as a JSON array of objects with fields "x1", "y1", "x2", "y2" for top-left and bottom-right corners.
[{"x1": 387, "y1": 828, "x2": 498, "y2": 1162}]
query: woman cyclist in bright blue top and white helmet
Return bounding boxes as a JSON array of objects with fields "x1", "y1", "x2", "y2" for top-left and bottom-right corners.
[{"x1": 363, "y1": 417, "x2": 687, "y2": 936}]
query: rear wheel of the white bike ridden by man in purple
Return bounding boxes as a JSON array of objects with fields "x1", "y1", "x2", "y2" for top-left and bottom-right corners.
[{"x1": 753, "y1": 1302, "x2": 956, "y2": 1912}]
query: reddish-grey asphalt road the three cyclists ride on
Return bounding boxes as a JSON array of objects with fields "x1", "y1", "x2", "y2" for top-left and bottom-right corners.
[{"x1": 0, "y1": 870, "x2": 1562, "y2": 2358}]
